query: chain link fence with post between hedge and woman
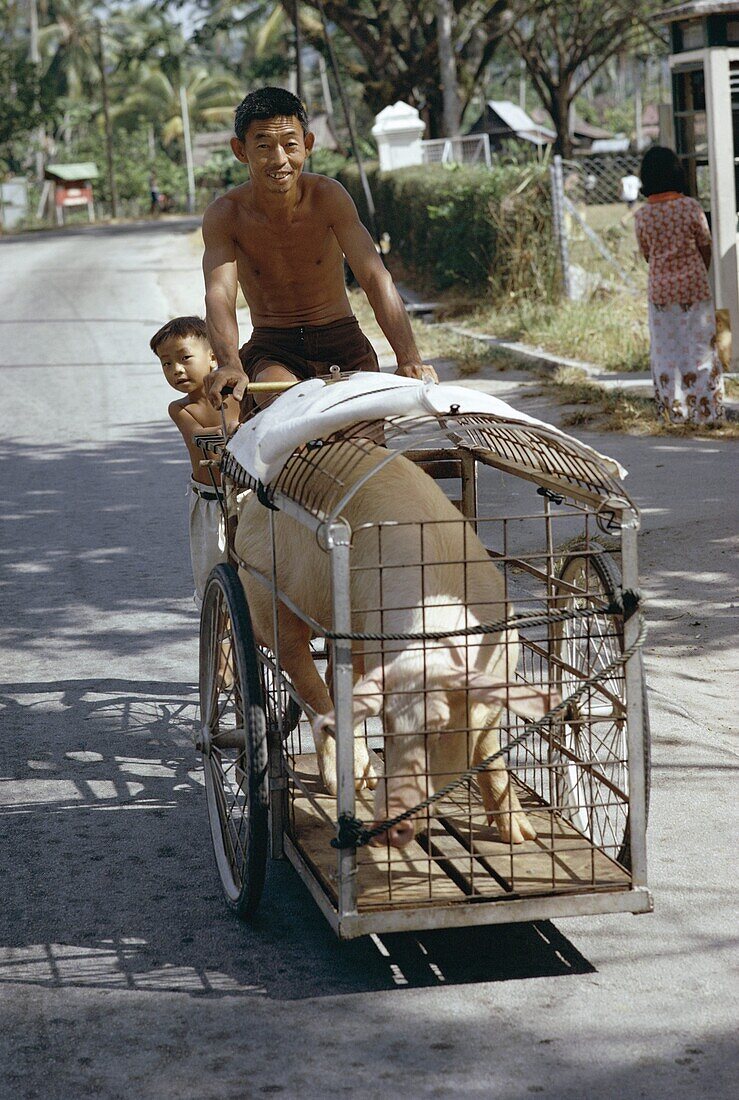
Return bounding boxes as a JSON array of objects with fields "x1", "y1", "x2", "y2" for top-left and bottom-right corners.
[{"x1": 551, "y1": 153, "x2": 647, "y2": 299}]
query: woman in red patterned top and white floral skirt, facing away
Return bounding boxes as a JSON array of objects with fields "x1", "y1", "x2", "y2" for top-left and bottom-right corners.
[{"x1": 636, "y1": 145, "x2": 724, "y2": 424}]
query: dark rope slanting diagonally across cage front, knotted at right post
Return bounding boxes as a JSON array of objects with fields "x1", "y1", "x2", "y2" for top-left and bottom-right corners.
[{"x1": 331, "y1": 590, "x2": 647, "y2": 849}]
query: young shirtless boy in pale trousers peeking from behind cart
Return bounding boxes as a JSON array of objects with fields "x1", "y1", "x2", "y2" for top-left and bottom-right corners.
[{"x1": 150, "y1": 317, "x2": 239, "y2": 607}]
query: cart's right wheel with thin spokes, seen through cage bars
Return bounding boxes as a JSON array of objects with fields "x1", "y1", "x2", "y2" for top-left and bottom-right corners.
[{"x1": 553, "y1": 542, "x2": 650, "y2": 867}]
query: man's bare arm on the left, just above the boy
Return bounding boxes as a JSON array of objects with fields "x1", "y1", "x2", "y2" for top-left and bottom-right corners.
[{"x1": 202, "y1": 199, "x2": 247, "y2": 408}]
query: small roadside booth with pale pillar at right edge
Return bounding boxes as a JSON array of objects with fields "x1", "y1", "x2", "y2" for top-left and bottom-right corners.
[{"x1": 662, "y1": 0, "x2": 739, "y2": 370}]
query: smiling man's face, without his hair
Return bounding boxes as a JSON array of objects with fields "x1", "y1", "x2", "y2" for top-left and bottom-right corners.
[{"x1": 231, "y1": 117, "x2": 315, "y2": 195}]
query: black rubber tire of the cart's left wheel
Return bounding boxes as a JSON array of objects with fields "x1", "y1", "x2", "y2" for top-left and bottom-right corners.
[{"x1": 200, "y1": 563, "x2": 269, "y2": 920}]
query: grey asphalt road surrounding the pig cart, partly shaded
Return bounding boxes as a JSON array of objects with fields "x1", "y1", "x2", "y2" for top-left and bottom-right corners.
[{"x1": 0, "y1": 222, "x2": 738, "y2": 1100}]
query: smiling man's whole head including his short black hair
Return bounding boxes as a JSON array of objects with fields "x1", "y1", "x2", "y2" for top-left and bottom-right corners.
[{"x1": 231, "y1": 88, "x2": 315, "y2": 194}]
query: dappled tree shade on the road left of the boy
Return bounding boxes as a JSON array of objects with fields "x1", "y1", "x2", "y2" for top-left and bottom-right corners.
[{"x1": 0, "y1": 422, "x2": 197, "y2": 662}]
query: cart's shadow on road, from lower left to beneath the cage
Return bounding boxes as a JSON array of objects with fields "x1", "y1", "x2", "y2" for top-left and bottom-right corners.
[{"x1": 0, "y1": 679, "x2": 593, "y2": 1000}]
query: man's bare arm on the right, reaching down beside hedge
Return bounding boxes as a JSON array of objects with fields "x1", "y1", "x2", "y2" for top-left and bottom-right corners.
[{"x1": 327, "y1": 183, "x2": 435, "y2": 378}]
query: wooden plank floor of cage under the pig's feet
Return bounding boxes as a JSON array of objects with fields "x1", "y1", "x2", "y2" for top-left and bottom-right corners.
[{"x1": 290, "y1": 754, "x2": 631, "y2": 912}]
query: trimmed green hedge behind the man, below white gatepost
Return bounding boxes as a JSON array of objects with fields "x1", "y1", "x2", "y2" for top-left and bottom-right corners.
[{"x1": 338, "y1": 164, "x2": 555, "y2": 296}]
